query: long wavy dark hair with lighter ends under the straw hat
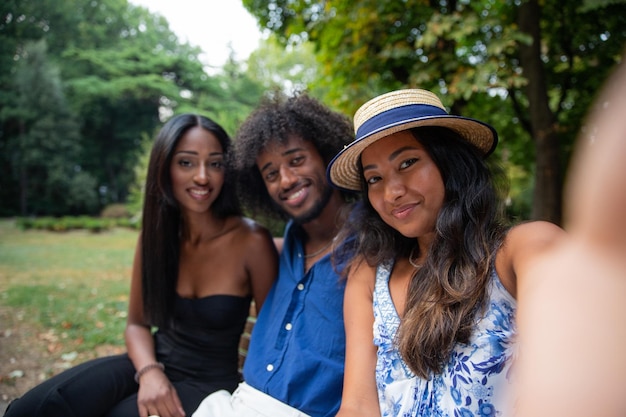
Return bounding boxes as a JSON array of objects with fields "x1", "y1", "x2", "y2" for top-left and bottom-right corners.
[{"x1": 347, "y1": 127, "x2": 506, "y2": 378}]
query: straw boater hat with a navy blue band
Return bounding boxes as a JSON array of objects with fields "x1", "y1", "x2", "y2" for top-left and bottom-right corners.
[{"x1": 327, "y1": 89, "x2": 498, "y2": 191}]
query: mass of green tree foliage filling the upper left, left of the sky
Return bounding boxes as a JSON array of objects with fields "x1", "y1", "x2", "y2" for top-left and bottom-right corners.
[{"x1": 0, "y1": 0, "x2": 263, "y2": 215}]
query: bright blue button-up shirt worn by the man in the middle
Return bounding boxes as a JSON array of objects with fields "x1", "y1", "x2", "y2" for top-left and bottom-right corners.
[{"x1": 243, "y1": 222, "x2": 346, "y2": 417}]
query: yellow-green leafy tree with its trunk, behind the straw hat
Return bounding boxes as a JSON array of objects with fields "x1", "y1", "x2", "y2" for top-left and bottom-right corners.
[{"x1": 243, "y1": 0, "x2": 626, "y2": 222}]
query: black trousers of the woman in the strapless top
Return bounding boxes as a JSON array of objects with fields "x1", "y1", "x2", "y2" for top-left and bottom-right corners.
[{"x1": 4, "y1": 354, "x2": 208, "y2": 417}]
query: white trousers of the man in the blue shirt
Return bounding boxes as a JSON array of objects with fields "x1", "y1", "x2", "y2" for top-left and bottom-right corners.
[{"x1": 192, "y1": 382, "x2": 310, "y2": 417}]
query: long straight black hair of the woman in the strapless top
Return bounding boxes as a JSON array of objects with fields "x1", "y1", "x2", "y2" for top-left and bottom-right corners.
[{"x1": 141, "y1": 114, "x2": 241, "y2": 326}]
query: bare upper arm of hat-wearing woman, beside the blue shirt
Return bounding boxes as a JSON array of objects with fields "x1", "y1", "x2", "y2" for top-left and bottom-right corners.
[{"x1": 337, "y1": 262, "x2": 380, "y2": 417}]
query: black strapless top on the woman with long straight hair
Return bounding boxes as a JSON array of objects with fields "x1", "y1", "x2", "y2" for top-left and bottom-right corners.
[{"x1": 154, "y1": 295, "x2": 251, "y2": 392}]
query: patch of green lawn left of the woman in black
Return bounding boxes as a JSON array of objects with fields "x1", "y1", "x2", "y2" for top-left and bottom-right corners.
[{"x1": 0, "y1": 219, "x2": 138, "y2": 352}]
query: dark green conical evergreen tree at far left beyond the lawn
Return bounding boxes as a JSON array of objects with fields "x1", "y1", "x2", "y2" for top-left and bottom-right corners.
[{"x1": 3, "y1": 40, "x2": 97, "y2": 214}]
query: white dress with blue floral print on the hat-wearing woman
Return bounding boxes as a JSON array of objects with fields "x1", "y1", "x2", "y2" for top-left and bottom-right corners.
[{"x1": 374, "y1": 265, "x2": 516, "y2": 417}]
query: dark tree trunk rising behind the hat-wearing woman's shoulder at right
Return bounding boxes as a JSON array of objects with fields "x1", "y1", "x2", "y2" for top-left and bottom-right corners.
[{"x1": 518, "y1": 0, "x2": 562, "y2": 224}]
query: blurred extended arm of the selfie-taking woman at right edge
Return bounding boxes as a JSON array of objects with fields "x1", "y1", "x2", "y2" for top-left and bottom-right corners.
[{"x1": 517, "y1": 55, "x2": 626, "y2": 417}]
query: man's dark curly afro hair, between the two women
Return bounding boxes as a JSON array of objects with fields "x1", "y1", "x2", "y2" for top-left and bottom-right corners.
[{"x1": 235, "y1": 93, "x2": 354, "y2": 220}]
